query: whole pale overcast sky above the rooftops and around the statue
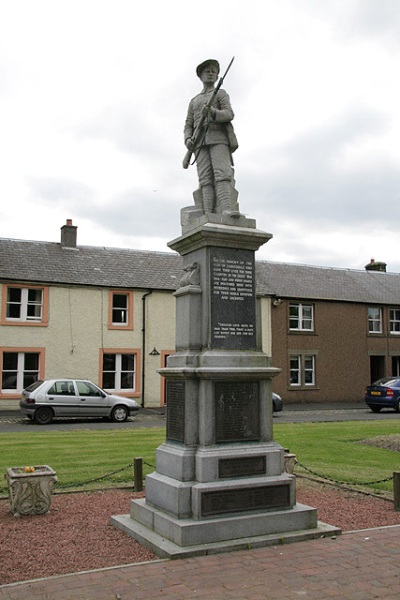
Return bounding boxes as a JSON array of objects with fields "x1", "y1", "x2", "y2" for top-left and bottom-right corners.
[{"x1": 0, "y1": 0, "x2": 400, "y2": 272}]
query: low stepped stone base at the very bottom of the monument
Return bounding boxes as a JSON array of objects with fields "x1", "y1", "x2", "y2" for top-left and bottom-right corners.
[{"x1": 111, "y1": 500, "x2": 341, "y2": 559}]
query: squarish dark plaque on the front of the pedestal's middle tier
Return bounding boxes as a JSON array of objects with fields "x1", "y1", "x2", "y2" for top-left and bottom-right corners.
[{"x1": 214, "y1": 381, "x2": 260, "y2": 444}]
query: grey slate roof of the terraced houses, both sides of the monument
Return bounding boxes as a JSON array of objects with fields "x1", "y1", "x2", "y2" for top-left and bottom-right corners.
[{"x1": 0, "y1": 239, "x2": 400, "y2": 306}]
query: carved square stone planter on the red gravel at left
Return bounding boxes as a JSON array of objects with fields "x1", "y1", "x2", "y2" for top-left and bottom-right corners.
[{"x1": 5, "y1": 465, "x2": 57, "y2": 516}]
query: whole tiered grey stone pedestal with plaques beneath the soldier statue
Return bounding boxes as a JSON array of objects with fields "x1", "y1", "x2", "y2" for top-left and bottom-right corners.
[{"x1": 112, "y1": 211, "x2": 338, "y2": 557}]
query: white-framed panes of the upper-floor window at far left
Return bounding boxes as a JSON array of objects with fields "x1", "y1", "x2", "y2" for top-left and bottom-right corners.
[{"x1": 5, "y1": 286, "x2": 44, "y2": 322}]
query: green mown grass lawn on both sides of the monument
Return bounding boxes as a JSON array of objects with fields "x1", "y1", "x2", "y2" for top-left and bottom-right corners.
[{"x1": 0, "y1": 421, "x2": 400, "y2": 494}]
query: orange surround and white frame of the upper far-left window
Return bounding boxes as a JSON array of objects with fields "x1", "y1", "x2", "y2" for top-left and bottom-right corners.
[{"x1": 0, "y1": 283, "x2": 49, "y2": 327}]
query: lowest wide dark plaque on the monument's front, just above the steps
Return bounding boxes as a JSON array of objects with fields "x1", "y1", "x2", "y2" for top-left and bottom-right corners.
[{"x1": 201, "y1": 483, "x2": 290, "y2": 517}]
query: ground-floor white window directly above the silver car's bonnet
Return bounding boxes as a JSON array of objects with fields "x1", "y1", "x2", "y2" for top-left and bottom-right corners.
[{"x1": 103, "y1": 353, "x2": 136, "y2": 392}]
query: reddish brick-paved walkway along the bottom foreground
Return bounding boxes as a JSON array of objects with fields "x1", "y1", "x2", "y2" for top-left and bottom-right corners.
[{"x1": 0, "y1": 526, "x2": 400, "y2": 600}]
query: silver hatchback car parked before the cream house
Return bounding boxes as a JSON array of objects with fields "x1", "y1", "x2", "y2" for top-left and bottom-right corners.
[{"x1": 19, "y1": 379, "x2": 139, "y2": 425}]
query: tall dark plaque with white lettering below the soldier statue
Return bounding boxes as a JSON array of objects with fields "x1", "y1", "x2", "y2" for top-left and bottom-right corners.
[{"x1": 210, "y1": 248, "x2": 256, "y2": 350}]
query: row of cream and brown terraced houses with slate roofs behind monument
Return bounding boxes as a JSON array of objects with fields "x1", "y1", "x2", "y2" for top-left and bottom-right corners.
[{"x1": 0, "y1": 220, "x2": 400, "y2": 407}]
